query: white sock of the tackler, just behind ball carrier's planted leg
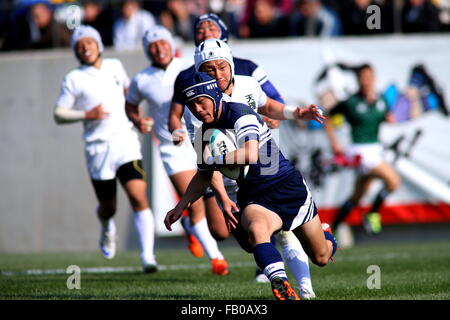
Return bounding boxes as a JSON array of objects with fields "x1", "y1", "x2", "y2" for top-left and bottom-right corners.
[{"x1": 277, "y1": 231, "x2": 312, "y2": 291}]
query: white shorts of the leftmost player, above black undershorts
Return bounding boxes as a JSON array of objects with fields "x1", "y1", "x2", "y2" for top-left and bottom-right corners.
[{"x1": 85, "y1": 130, "x2": 142, "y2": 180}]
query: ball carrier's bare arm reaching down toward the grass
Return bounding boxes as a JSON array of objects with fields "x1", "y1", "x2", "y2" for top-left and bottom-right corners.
[{"x1": 164, "y1": 170, "x2": 213, "y2": 231}]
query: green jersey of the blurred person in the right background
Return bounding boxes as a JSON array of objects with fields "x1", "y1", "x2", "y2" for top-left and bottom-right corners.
[{"x1": 330, "y1": 94, "x2": 388, "y2": 143}]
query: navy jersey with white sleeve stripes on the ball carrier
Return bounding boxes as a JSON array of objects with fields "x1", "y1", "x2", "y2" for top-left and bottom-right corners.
[{"x1": 197, "y1": 101, "x2": 294, "y2": 194}]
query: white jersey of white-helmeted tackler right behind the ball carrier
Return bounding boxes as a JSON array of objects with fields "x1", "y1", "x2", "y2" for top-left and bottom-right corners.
[{"x1": 184, "y1": 75, "x2": 267, "y2": 141}]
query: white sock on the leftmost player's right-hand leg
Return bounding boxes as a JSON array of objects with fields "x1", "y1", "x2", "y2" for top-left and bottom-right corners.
[{"x1": 133, "y1": 208, "x2": 155, "y2": 263}]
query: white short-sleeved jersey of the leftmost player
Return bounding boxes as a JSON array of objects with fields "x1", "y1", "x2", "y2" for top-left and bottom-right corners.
[{"x1": 56, "y1": 59, "x2": 133, "y2": 143}]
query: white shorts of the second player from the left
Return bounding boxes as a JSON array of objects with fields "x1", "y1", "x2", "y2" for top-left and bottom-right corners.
[{"x1": 159, "y1": 139, "x2": 197, "y2": 177}]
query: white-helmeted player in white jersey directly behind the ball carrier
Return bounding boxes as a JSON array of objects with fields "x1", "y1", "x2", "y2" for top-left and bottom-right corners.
[{"x1": 185, "y1": 39, "x2": 315, "y2": 298}]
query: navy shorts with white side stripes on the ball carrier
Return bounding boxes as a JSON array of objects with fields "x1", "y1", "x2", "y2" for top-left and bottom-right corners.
[{"x1": 237, "y1": 170, "x2": 317, "y2": 231}]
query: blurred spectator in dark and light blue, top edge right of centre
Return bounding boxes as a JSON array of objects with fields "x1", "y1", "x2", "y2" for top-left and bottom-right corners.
[{"x1": 290, "y1": 0, "x2": 342, "y2": 37}]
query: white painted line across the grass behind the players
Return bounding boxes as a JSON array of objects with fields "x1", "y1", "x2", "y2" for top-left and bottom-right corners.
[{"x1": 0, "y1": 253, "x2": 411, "y2": 276}]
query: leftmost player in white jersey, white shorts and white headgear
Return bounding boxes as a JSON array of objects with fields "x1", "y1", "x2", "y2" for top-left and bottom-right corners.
[{"x1": 54, "y1": 26, "x2": 157, "y2": 272}]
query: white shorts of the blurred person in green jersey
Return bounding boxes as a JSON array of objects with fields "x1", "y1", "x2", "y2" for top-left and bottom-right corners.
[{"x1": 345, "y1": 143, "x2": 383, "y2": 173}]
